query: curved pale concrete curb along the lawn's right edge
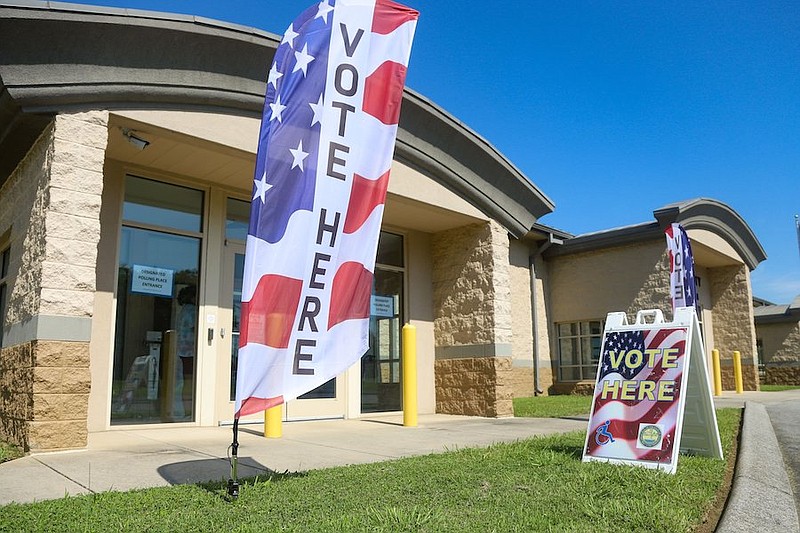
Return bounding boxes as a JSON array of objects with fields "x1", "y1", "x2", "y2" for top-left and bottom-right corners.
[{"x1": 717, "y1": 401, "x2": 800, "y2": 533}]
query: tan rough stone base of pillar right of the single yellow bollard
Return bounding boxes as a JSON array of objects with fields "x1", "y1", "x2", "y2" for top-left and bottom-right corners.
[{"x1": 435, "y1": 357, "x2": 514, "y2": 417}]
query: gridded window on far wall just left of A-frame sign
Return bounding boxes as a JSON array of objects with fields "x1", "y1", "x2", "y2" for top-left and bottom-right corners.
[{"x1": 556, "y1": 320, "x2": 603, "y2": 381}]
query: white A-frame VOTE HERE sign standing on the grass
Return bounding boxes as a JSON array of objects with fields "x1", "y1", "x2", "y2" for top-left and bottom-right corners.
[{"x1": 583, "y1": 307, "x2": 722, "y2": 474}]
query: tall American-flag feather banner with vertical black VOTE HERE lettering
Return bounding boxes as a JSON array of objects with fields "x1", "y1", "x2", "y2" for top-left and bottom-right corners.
[{"x1": 234, "y1": 0, "x2": 419, "y2": 418}]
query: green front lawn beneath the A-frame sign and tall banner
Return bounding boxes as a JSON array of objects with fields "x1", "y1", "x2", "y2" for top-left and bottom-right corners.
[{"x1": 0, "y1": 409, "x2": 740, "y2": 533}]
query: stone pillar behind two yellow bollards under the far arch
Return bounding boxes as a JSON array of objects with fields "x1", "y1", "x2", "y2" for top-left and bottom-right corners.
[{"x1": 708, "y1": 265, "x2": 759, "y2": 390}]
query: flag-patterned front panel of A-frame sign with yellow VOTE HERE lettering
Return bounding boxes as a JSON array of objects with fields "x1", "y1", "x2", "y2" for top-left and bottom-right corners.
[{"x1": 584, "y1": 327, "x2": 688, "y2": 470}]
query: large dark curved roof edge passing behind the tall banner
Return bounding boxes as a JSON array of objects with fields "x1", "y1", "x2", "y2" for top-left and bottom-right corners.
[{"x1": 0, "y1": 1, "x2": 554, "y2": 237}]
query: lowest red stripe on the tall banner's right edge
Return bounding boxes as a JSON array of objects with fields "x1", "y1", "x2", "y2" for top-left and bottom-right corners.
[{"x1": 328, "y1": 261, "x2": 372, "y2": 329}]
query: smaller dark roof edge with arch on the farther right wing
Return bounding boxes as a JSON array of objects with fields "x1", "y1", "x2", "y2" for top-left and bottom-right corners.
[{"x1": 546, "y1": 198, "x2": 767, "y2": 270}]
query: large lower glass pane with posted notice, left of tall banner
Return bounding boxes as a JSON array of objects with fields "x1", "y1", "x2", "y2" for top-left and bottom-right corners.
[{"x1": 111, "y1": 227, "x2": 201, "y2": 424}]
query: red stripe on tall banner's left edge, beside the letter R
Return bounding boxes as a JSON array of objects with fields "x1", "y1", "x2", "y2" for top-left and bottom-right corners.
[{"x1": 239, "y1": 274, "x2": 303, "y2": 348}]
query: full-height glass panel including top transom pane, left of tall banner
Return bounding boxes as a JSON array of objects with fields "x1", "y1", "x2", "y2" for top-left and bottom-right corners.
[{"x1": 111, "y1": 176, "x2": 203, "y2": 424}]
